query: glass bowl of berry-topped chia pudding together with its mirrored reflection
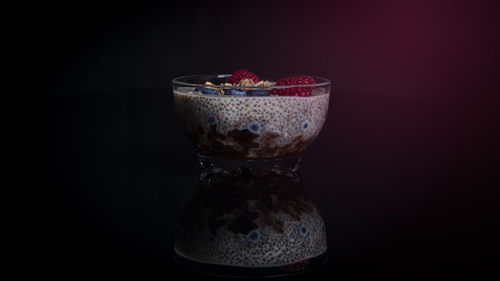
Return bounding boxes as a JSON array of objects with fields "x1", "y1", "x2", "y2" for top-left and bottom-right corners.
[{"x1": 172, "y1": 70, "x2": 331, "y2": 276}]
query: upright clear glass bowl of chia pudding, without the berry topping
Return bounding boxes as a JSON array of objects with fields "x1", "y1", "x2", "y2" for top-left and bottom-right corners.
[{"x1": 173, "y1": 75, "x2": 330, "y2": 159}]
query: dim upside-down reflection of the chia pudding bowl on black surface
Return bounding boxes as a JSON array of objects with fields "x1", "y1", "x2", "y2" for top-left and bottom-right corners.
[{"x1": 175, "y1": 171, "x2": 327, "y2": 271}]
